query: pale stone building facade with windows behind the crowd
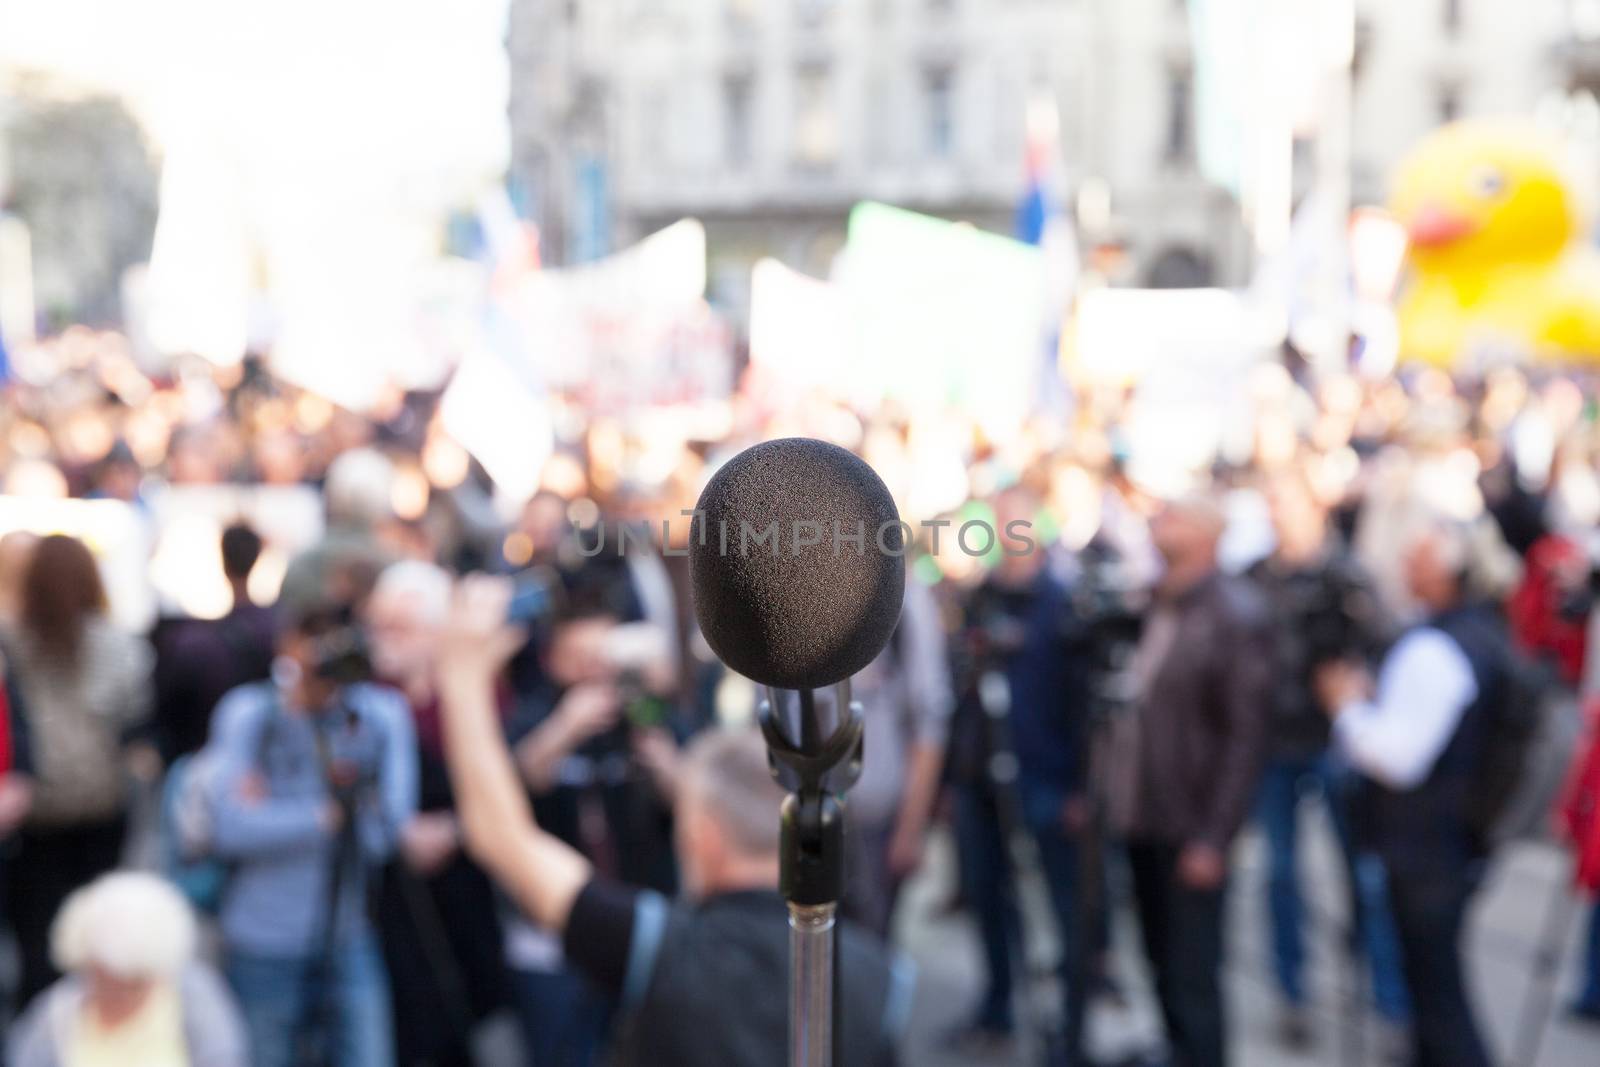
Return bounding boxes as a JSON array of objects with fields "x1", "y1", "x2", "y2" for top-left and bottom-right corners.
[{"x1": 507, "y1": 0, "x2": 1600, "y2": 314}]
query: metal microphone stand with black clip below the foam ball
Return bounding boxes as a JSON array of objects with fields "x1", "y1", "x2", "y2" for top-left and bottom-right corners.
[{"x1": 760, "y1": 680, "x2": 862, "y2": 1067}]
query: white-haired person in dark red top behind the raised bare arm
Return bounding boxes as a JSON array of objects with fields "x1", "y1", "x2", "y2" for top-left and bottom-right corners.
[{"x1": 366, "y1": 560, "x2": 509, "y2": 1067}]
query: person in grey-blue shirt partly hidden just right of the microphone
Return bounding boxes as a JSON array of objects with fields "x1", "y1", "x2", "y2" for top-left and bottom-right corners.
[{"x1": 845, "y1": 576, "x2": 954, "y2": 937}]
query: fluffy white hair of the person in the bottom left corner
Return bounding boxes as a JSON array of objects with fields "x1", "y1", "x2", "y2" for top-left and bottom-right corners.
[{"x1": 50, "y1": 870, "x2": 195, "y2": 979}]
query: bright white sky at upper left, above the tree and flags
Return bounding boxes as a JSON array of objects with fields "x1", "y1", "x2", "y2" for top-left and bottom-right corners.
[{"x1": 0, "y1": 0, "x2": 507, "y2": 192}]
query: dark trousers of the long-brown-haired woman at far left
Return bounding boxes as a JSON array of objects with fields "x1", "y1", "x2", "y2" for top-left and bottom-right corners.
[{"x1": 6, "y1": 816, "x2": 128, "y2": 1009}]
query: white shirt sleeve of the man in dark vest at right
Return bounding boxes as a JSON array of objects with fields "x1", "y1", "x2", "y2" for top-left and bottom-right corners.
[{"x1": 1333, "y1": 627, "x2": 1478, "y2": 789}]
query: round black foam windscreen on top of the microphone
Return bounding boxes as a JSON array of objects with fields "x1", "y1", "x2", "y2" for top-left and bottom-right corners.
[{"x1": 690, "y1": 437, "x2": 907, "y2": 689}]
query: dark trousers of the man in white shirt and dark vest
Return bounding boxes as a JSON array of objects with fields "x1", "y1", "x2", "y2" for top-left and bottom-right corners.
[{"x1": 1389, "y1": 867, "x2": 1490, "y2": 1067}]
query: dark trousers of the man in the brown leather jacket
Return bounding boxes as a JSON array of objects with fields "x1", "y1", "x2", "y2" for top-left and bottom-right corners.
[{"x1": 1128, "y1": 841, "x2": 1227, "y2": 1067}]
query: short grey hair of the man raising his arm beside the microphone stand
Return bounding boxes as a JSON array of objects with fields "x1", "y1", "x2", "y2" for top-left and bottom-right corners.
[{"x1": 683, "y1": 728, "x2": 784, "y2": 857}]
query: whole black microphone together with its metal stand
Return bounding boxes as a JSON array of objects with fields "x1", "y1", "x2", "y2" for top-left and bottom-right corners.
[{"x1": 690, "y1": 437, "x2": 906, "y2": 1067}]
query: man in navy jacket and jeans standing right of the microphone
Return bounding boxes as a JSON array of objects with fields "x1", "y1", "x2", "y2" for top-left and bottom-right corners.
[{"x1": 952, "y1": 485, "x2": 1099, "y2": 1046}]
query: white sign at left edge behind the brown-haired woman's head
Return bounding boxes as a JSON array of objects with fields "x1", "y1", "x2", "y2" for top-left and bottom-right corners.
[{"x1": 0, "y1": 496, "x2": 155, "y2": 633}]
